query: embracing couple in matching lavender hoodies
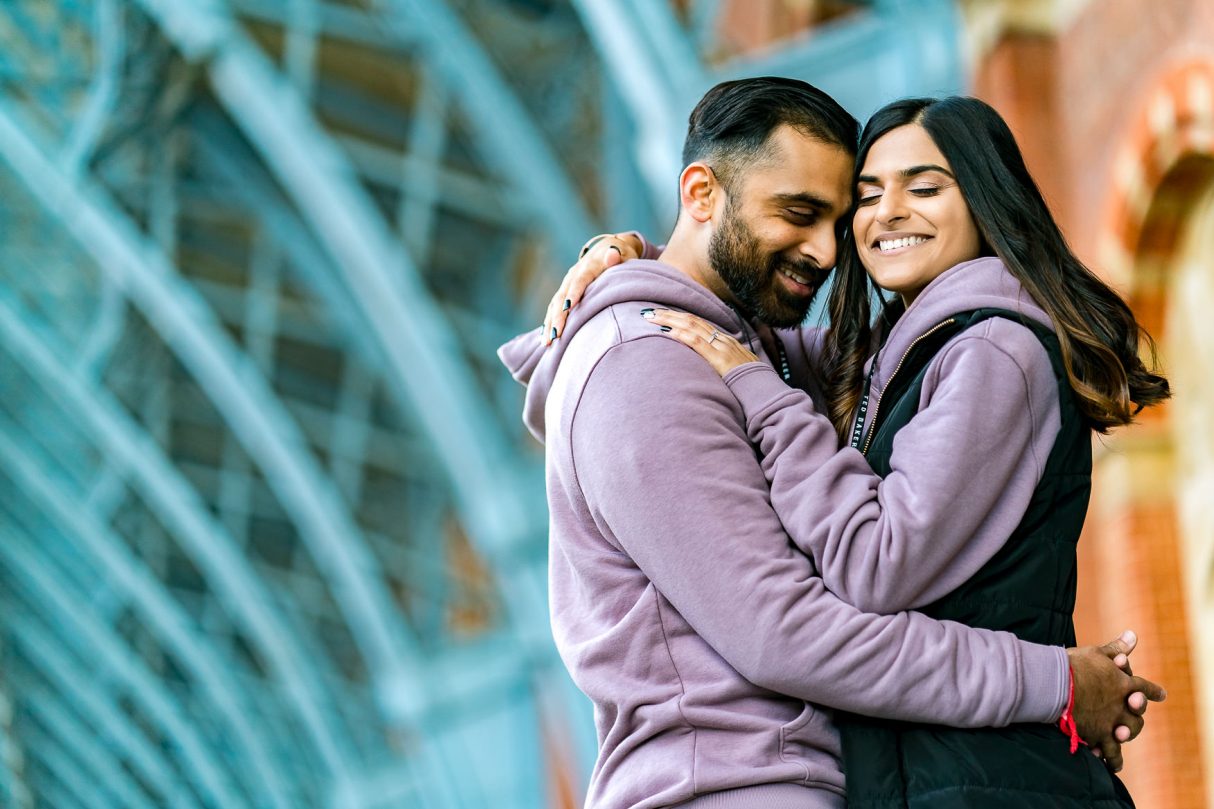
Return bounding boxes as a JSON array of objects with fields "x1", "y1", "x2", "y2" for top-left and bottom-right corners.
[{"x1": 499, "y1": 78, "x2": 1168, "y2": 809}]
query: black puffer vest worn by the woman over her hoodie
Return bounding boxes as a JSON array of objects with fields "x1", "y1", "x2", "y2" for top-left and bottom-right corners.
[{"x1": 838, "y1": 309, "x2": 1133, "y2": 809}]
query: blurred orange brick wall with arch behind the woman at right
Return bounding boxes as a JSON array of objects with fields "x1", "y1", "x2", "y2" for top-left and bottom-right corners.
[{"x1": 974, "y1": 0, "x2": 1214, "y2": 809}]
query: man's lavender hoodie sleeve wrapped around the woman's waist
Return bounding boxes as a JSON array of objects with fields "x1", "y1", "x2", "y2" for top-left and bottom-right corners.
[{"x1": 571, "y1": 336, "x2": 1067, "y2": 726}]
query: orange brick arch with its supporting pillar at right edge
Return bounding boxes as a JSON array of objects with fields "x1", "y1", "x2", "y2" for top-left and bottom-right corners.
[{"x1": 1079, "y1": 53, "x2": 1214, "y2": 809}]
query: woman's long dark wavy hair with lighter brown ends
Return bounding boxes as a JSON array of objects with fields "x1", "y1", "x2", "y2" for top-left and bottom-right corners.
[{"x1": 823, "y1": 96, "x2": 1170, "y2": 440}]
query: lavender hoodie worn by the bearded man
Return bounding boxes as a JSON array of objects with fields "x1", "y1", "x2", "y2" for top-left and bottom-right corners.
[{"x1": 499, "y1": 260, "x2": 1067, "y2": 809}]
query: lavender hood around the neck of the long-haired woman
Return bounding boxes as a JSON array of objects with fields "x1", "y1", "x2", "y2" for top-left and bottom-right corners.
[{"x1": 870, "y1": 256, "x2": 1054, "y2": 391}]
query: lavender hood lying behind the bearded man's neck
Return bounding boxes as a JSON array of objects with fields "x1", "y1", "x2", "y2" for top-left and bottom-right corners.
[{"x1": 498, "y1": 259, "x2": 764, "y2": 441}]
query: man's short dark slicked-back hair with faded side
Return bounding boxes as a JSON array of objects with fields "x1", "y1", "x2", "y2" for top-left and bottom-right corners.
[{"x1": 682, "y1": 77, "x2": 860, "y2": 191}]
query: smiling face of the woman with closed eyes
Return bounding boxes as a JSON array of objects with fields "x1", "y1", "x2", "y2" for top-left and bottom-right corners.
[{"x1": 852, "y1": 124, "x2": 982, "y2": 306}]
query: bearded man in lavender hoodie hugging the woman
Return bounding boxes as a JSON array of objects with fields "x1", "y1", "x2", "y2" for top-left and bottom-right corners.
[{"x1": 500, "y1": 78, "x2": 1157, "y2": 809}]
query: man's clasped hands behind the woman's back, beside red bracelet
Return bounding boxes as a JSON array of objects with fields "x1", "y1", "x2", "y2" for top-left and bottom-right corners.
[{"x1": 1066, "y1": 632, "x2": 1167, "y2": 773}]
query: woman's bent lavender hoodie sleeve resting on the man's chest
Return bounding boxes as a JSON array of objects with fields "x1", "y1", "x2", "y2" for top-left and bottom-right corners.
[{"x1": 726, "y1": 321, "x2": 1060, "y2": 613}]
